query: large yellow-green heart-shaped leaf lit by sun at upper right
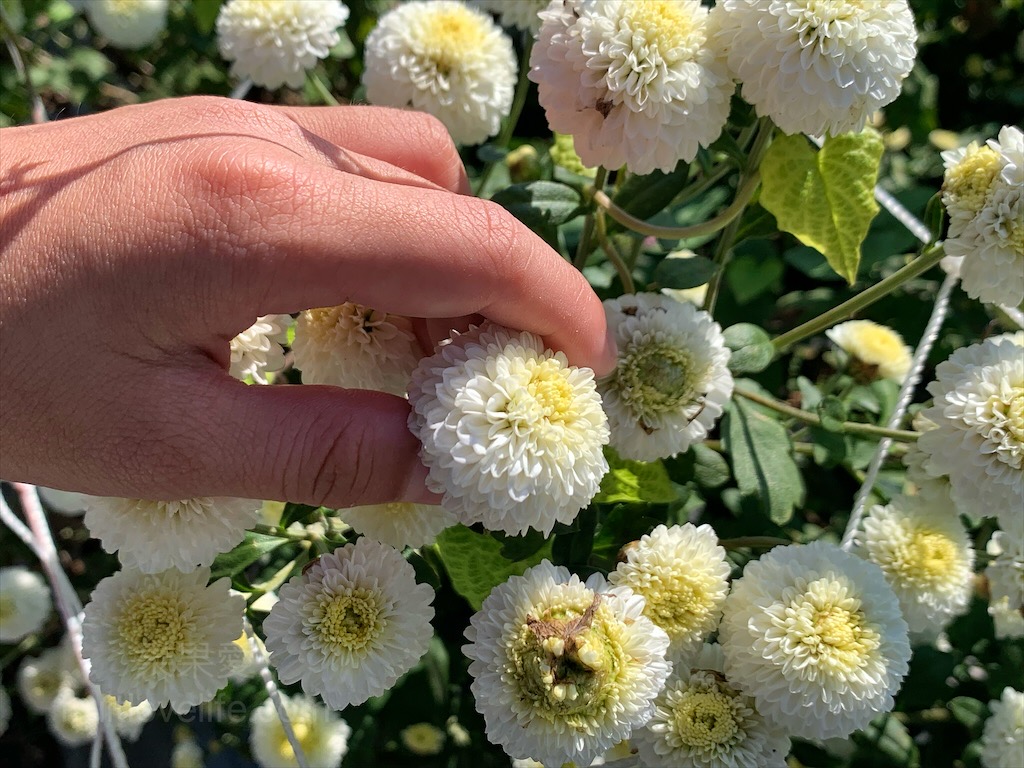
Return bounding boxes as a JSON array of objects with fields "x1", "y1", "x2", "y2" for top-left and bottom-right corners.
[{"x1": 760, "y1": 129, "x2": 885, "y2": 285}]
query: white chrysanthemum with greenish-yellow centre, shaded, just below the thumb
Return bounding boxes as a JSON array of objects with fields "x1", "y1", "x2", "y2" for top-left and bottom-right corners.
[{"x1": 263, "y1": 538, "x2": 434, "y2": 710}]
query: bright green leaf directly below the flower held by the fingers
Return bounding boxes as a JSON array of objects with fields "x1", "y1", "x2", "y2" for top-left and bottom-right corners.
[{"x1": 436, "y1": 525, "x2": 551, "y2": 610}]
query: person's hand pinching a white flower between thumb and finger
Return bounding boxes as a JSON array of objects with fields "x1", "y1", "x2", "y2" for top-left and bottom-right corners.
[{"x1": 0, "y1": 97, "x2": 614, "y2": 514}]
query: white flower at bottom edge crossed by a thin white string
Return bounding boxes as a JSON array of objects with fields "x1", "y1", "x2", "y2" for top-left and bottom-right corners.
[{"x1": 249, "y1": 693, "x2": 352, "y2": 768}]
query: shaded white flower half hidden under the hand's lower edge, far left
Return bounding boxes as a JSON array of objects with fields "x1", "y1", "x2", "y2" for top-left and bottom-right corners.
[{"x1": 85, "y1": 497, "x2": 262, "y2": 573}]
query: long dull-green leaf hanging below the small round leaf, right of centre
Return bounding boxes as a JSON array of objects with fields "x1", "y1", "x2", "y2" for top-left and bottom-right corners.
[{"x1": 722, "y1": 398, "x2": 804, "y2": 525}]
